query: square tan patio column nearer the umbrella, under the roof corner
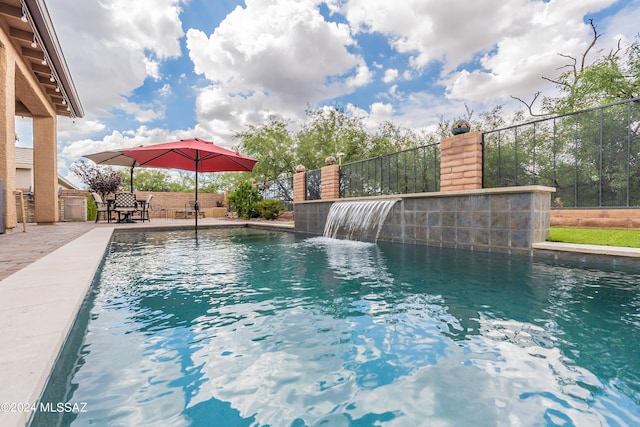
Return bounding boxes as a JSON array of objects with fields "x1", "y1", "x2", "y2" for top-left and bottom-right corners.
[{"x1": 33, "y1": 116, "x2": 59, "y2": 224}]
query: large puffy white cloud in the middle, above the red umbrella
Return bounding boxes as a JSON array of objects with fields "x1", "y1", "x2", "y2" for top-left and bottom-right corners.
[{"x1": 187, "y1": 0, "x2": 364, "y2": 130}]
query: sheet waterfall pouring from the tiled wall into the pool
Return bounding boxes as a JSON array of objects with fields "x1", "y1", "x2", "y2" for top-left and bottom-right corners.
[{"x1": 323, "y1": 200, "x2": 397, "y2": 242}]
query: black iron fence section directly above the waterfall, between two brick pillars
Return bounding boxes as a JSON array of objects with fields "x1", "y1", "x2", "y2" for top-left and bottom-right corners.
[{"x1": 340, "y1": 144, "x2": 440, "y2": 197}]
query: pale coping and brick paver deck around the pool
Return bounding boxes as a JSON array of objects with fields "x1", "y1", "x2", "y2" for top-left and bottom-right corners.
[{"x1": 0, "y1": 219, "x2": 640, "y2": 427}]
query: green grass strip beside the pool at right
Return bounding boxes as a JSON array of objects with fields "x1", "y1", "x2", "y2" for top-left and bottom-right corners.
[{"x1": 547, "y1": 227, "x2": 640, "y2": 248}]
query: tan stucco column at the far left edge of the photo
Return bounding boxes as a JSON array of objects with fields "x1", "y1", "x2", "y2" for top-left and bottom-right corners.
[{"x1": 0, "y1": 42, "x2": 18, "y2": 231}]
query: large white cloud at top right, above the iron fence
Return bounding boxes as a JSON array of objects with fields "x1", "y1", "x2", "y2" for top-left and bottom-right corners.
[{"x1": 331, "y1": 0, "x2": 624, "y2": 106}]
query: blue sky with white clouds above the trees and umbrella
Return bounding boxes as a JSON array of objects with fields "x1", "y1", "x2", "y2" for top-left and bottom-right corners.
[{"x1": 16, "y1": 0, "x2": 640, "y2": 182}]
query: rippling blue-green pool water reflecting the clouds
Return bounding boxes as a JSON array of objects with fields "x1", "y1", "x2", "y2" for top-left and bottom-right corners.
[{"x1": 32, "y1": 229, "x2": 640, "y2": 427}]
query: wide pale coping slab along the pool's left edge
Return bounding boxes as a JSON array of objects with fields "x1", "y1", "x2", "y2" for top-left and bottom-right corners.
[{"x1": 0, "y1": 227, "x2": 114, "y2": 426}]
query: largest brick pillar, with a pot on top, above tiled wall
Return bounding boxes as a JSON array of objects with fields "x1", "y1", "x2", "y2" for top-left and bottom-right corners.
[{"x1": 440, "y1": 132, "x2": 482, "y2": 191}]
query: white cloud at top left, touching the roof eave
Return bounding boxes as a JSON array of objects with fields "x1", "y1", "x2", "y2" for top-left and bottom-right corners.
[{"x1": 47, "y1": 0, "x2": 183, "y2": 116}]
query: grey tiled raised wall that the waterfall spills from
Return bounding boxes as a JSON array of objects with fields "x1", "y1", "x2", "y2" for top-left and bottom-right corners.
[{"x1": 294, "y1": 186, "x2": 554, "y2": 254}]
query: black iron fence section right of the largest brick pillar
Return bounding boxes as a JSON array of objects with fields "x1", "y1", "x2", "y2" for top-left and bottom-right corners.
[{"x1": 483, "y1": 98, "x2": 640, "y2": 207}]
